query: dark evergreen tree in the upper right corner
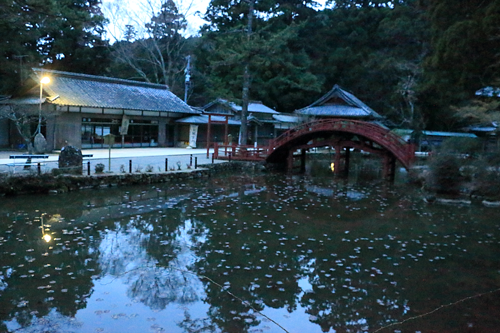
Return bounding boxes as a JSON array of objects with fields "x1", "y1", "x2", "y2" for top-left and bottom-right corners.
[{"x1": 420, "y1": 0, "x2": 500, "y2": 129}]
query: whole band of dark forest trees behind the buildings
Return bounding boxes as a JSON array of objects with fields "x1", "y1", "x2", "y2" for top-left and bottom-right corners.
[{"x1": 0, "y1": 0, "x2": 500, "y2": 130}]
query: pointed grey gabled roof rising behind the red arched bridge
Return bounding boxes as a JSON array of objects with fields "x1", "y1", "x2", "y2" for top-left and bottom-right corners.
[{"x1": 294, "y1": 85, "x2": 383, "y2": 119}]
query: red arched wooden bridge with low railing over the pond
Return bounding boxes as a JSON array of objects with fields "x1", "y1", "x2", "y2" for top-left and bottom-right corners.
[{"x1": 215, "y1": 119, "x2": 415, "y2": 177}]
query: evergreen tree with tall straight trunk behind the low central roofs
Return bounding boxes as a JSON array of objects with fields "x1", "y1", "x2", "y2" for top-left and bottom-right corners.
[{"x1": 197, "y1": 0, "x2": 319, "y2": 115}]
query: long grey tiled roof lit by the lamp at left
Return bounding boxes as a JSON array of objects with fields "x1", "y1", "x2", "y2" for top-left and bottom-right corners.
[{"x1": 33, "y1": 69, "x2": 199, "y2": 114}]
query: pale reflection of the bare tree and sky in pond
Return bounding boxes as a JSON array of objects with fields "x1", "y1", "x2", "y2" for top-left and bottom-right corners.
[{"x1": 99, "y1": 211, "x2": 206, "y2": 310}]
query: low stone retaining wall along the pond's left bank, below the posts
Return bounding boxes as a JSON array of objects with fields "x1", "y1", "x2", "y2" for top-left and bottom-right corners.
[{"x1": 0, "y1": 162, "x2": 251, "y2": 196}]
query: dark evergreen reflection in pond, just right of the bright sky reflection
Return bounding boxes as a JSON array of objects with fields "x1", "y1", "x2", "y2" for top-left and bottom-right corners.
[{"x1": 188, "y1": 177, "x2": 300, "y2": 332}]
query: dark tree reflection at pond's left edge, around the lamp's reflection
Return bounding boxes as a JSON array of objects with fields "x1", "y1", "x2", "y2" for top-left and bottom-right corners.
[{"x1": 0, "y1": 212, "x2": 99, "y2": 332}]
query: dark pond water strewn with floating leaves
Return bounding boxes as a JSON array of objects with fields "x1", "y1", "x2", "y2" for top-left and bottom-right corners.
[{"x1": 0, "y1": 157, "x2": 500, "y2": 333}]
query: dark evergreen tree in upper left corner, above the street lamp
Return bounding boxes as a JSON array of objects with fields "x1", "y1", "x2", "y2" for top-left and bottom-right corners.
[{"x1": 0, "y1": 0, "x2": 107, "y2": 93}]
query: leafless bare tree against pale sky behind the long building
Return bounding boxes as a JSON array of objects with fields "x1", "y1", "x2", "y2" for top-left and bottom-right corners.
[{"x1": 103, "y1": 0, "x2": 192, "y2": 92}]
